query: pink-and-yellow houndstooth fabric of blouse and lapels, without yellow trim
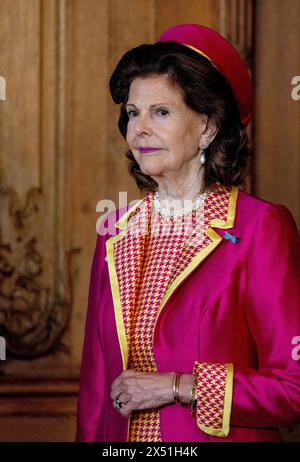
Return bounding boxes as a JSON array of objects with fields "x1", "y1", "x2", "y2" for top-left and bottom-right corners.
[{"x1": 114, "y1": 187, "x2": 231, "y2": 442}]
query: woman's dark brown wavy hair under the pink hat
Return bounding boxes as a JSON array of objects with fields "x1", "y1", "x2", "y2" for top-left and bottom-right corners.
[{"x1": 110, "y1": 42, "x2": 251, "y2": 191}]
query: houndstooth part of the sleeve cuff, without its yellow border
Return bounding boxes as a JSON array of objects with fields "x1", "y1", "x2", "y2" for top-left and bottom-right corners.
[{"x1": 193, "y1": 361, "x2": 227, "y2": 430}]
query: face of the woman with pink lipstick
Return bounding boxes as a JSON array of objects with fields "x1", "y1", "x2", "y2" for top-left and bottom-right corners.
[{"x1": 126, "y1": 75, "x2": 208, "y2": 177}]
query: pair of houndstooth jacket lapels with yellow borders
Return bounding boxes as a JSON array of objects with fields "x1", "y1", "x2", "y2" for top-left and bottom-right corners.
[{"x1": 106, "y1": 186, "x2": 239, "y2": 369}]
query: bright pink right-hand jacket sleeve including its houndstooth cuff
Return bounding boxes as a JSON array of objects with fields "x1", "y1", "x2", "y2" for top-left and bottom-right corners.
[{"x1": 193, "y1": 204, "x2": 300, "y2": 437}]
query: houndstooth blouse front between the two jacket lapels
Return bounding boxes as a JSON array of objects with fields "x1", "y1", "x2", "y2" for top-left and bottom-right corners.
[{"x1": 129, "y1": 196, "x2": 188, "y2": 442}]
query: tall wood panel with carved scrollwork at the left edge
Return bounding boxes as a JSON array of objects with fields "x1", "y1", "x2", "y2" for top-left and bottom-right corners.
[{"x1": 0, "y1": 0, "x2": 76, "y2": 376}]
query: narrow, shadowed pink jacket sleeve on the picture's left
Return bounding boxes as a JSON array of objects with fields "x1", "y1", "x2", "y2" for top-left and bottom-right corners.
[{"x1": 76, "y1": 235, "x2": 105, "y2": 441}]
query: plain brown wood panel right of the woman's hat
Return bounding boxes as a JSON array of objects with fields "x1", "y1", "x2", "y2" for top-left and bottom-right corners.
[{"x1": 255, "y1": 0, "x2": 300, "y2": 230}]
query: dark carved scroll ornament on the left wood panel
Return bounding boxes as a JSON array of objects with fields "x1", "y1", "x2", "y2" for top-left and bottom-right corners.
[{"x1": 0, "y1": 173, "x2": 78, "y2": 358}]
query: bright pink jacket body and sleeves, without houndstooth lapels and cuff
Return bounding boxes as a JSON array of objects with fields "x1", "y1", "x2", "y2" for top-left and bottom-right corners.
[{"x1": 76, "y1": 187, "x2": 300, "y2": 442}]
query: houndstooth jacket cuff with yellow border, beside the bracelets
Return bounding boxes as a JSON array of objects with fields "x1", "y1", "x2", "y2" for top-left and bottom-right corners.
[{"x1": 193, "y1": 361, "x2": 233, "y2": 438}]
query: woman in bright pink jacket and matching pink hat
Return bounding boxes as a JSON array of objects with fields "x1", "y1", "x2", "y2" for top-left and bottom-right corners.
[{"x1": 77, "y1": 24, "x2": 300, "y2": 442}]
